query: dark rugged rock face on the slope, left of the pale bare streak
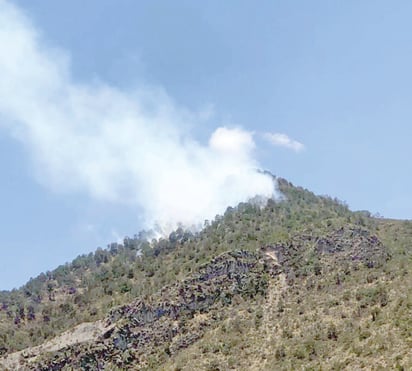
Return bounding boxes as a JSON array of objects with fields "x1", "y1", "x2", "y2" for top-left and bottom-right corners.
[{"x1": 24, "y1": 251, "x2": 268, "y2": 370}]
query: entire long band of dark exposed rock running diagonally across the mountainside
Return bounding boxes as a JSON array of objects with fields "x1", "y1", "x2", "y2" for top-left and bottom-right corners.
[{"x1": 0, "y1": 227, "x2": 389, "y2": 370}]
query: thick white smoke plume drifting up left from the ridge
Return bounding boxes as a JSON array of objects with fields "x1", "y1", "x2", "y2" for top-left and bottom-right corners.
[{"x1": 0, "y1": 0, "x2": 274, "y2": 235}]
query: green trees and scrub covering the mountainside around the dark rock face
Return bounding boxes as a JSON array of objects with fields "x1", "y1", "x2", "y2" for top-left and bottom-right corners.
[{"x1": 0, "y1": 179, "x2": 412, "y2": 370}]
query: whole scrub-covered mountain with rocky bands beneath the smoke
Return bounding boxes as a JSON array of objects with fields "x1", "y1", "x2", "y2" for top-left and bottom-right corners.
[{"x1": 0, "y1": 178, "x2": 412, "y2": 370}]
